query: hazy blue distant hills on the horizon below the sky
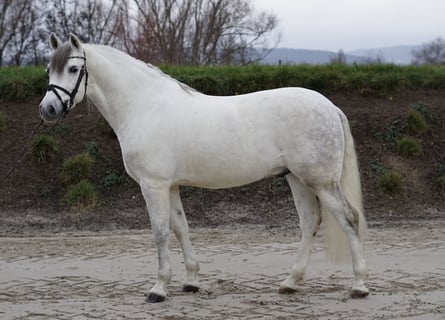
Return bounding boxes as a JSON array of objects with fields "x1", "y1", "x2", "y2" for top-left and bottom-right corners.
[{"x1": 261, "y1": 46, "x2": 415, "y2": 65}]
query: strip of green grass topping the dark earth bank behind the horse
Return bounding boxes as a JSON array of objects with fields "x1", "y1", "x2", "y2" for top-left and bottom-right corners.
[{"x1": 0, "y1": 64, "x2": 445, "y2": 101}]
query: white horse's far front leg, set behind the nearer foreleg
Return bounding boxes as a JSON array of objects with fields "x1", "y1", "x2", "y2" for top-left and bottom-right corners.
[{"x1": 170, "y1": 187, "x2": 199, "y2": 292}]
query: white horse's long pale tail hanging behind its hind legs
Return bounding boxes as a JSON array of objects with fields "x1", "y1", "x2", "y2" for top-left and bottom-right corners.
[{"x1": 323, "y1": 111, "x2": 367, "y2": 263}]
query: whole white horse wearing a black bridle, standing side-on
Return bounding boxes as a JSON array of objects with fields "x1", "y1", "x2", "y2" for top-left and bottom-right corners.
[{"x1": 40, "y1": 34, "x2": 369, "y2": 302}]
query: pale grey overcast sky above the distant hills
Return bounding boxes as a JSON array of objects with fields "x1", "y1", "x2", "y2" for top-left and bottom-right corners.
[{"x1": 252, "y1": 0, "x2": 445, "y2": 51}]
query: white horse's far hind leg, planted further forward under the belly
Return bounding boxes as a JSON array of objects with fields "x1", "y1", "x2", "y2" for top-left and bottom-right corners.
[{"x1": 279, "y1": 174, "x2": 321, "y2": 293}]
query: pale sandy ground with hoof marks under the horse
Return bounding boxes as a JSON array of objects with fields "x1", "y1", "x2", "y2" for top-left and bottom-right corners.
[{"x1": 0, "y1": 221, "x2": 445, "y2": 320}]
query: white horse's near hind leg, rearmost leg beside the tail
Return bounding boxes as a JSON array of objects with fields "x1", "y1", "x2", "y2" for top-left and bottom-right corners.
[{"x1": 317, "y1": 184, "x2": 369, "y2": 298}]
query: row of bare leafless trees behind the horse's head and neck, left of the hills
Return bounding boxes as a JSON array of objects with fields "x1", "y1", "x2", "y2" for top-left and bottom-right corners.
[{"x1": 0, "y1": 0, "x2": 277, "y2": 65}]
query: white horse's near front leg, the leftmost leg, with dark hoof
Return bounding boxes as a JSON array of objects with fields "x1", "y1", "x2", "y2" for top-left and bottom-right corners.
[{"x1": 141, "y1": 183, "x2": 172, "y2": 302}]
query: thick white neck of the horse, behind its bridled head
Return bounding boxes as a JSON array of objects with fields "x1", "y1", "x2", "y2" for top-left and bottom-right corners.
[{"x1": 85, "y1": 45, "x2": 186, "y2": 137}]
